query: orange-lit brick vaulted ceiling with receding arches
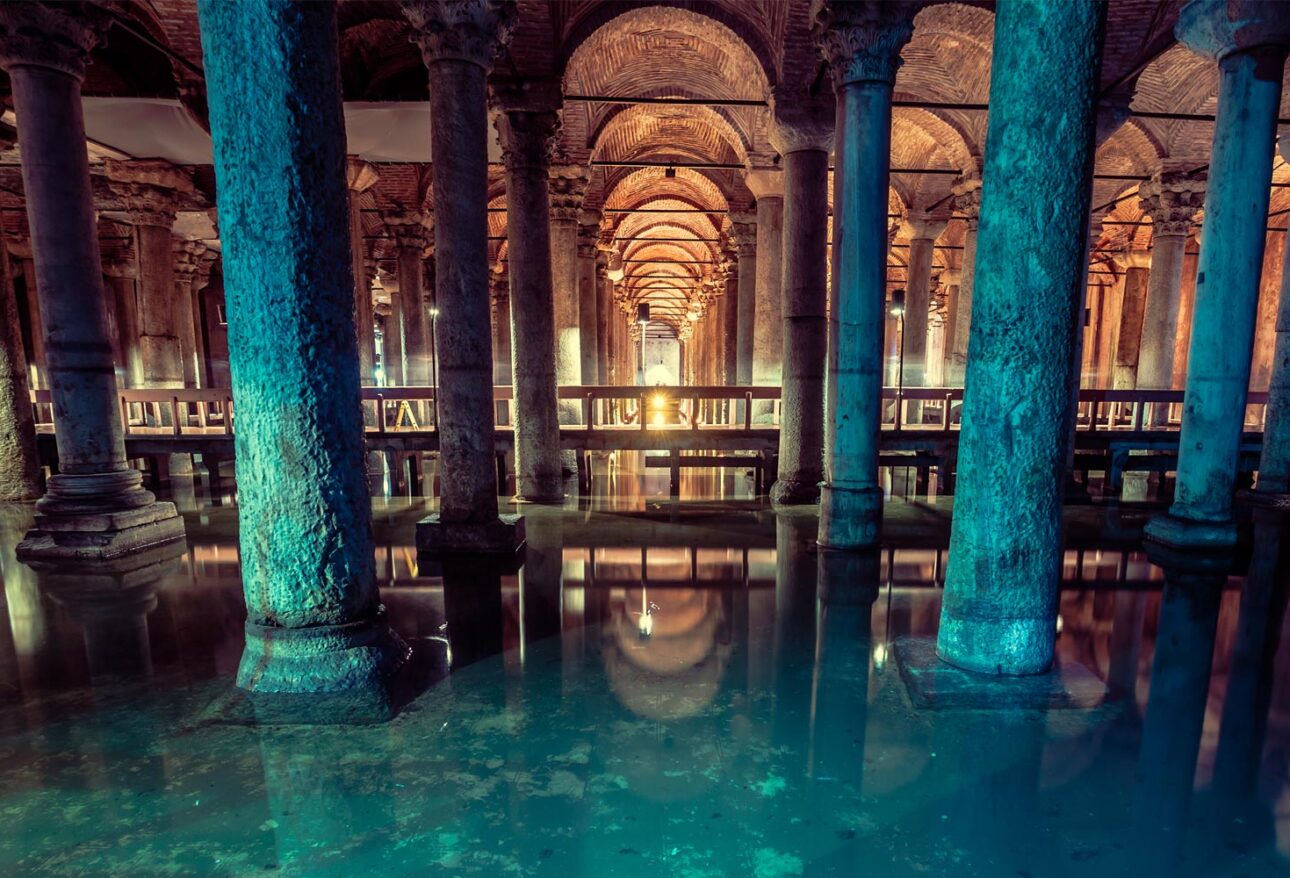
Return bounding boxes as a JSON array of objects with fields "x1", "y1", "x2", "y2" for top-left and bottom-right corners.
[{"x1": 0, "y1": 0, "x2": 1290, "y2": 332}]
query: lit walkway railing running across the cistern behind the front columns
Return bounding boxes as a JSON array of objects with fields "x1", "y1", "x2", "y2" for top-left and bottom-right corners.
[{"x1": 31, "y1": 385, "x2": 1268, "y2": 437}]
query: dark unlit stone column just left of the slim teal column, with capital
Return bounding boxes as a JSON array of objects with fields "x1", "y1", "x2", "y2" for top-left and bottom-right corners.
[{"x1": 759, "y1": 95, "x2": 835, "y2": 504}]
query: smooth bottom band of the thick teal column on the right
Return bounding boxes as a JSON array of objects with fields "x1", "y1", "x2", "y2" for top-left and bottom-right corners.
[{"x1": 937, "y1": 612, "x2": 1057, "y2": 677}]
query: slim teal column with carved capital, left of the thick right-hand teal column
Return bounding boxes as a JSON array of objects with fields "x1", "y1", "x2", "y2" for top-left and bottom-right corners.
[{"x1": 817, "y1": 3, "x2": 930, "y2": 549}]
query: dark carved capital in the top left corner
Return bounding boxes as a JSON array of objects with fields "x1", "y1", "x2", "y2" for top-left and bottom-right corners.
[{"x1": 0, "y1": 0, "x2": 111, "y2": 80}]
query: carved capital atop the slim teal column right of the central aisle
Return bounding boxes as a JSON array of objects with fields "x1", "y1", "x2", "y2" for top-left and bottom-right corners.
[{"x1": 811, "y1": 0, "x2": 922, "y2": 86}]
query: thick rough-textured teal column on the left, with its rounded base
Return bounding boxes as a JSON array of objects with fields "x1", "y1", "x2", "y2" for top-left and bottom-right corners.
[{"x1": 197, "y1": 0, "x2": 408, "y2": 695}]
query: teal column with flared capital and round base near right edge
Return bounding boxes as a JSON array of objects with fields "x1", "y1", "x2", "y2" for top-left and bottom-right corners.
[{"x1": 1146, "y1": 0, "x2": 1290, "y2": 548}]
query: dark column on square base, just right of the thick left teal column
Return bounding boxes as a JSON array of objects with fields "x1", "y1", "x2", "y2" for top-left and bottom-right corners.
[{"x1": 402, "y1": 0, "x2": 524, "y2": 553}]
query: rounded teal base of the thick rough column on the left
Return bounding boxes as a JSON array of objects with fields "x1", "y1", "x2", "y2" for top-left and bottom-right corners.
[{"x1": 237, "y1": 607, "x2": 412, "y2": 722}]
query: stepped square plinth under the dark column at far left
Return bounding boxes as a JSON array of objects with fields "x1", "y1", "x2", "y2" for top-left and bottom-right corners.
[{"x1": 17, "y1": 502, "x2": 183, "y2": 562}]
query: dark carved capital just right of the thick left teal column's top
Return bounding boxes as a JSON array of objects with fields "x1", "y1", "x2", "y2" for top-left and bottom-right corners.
[{"x1": 399, "y1": 0, "x2": 519, "y2": 72}]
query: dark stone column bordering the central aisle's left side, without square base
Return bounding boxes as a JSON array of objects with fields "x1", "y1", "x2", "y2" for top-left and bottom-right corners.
[{"x1": 494, "y1": 93, "x2": 568, "y2": 503}]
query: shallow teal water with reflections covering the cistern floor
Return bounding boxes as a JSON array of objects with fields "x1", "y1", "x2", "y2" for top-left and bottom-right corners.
[{"x1": 0, "y1": 461, "x2": 1290, "y2": 878}]
